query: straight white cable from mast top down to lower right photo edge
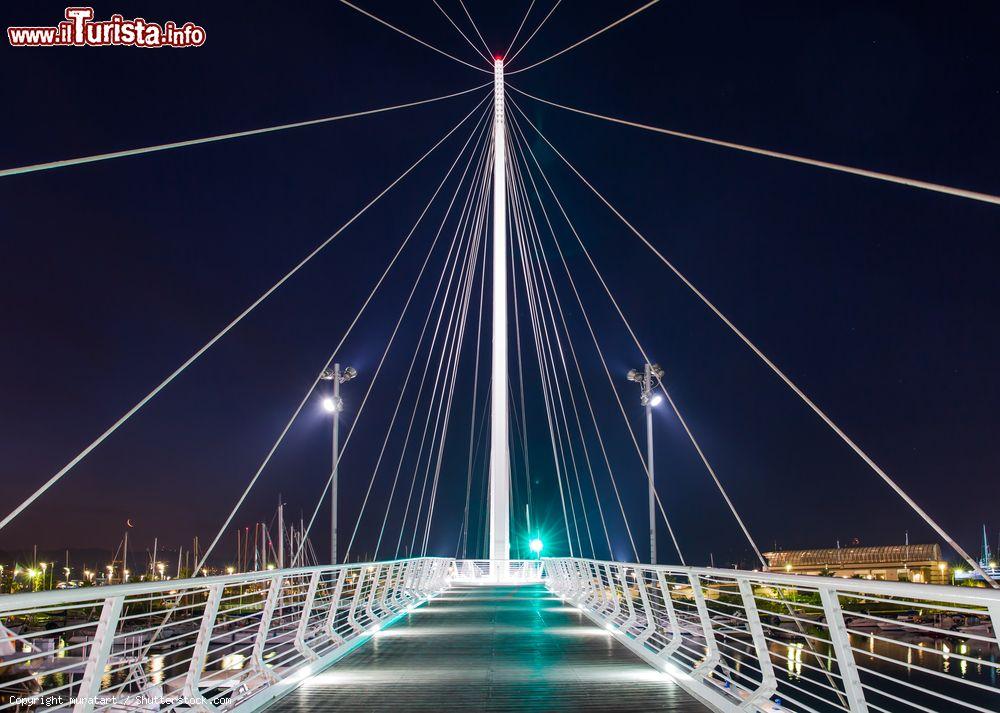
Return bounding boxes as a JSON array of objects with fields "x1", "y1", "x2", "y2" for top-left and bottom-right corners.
[{"x1": 511, "y1": 94, "x2": 1000, "y2": 589}]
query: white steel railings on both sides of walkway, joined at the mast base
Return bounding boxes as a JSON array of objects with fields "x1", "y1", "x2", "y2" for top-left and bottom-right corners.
[{"x1": 0, "y1": 558, "x2": 1000, "y2": 713}]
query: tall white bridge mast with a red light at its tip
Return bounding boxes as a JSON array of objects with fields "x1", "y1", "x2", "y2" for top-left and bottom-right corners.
[{"x1": 490, "y1": 58, "x2": 510, "y2": 579}]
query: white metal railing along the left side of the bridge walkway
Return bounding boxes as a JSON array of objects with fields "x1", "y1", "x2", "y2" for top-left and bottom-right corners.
[{"x1": 0, "y1": 558, "x2": 453, "y2": 713}]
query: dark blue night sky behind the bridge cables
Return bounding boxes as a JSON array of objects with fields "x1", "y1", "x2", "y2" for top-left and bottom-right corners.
[{"x1": 0, "y1": 0, "x2": 1000, "y2": 564}]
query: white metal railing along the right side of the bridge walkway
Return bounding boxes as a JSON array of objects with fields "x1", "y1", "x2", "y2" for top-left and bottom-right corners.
[{"x1": 545, "y1": 559, "x2": 1000, "y2": 713}]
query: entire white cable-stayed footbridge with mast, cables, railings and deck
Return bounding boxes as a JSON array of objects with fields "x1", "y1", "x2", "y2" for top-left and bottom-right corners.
[{"x1": 0, "y1": 0, "x2": 1000, "y2": 713}]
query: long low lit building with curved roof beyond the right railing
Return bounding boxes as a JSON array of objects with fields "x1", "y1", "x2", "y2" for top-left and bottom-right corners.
[{"x1": 764, "y1": 545, "x2": 948, "y2": 584}]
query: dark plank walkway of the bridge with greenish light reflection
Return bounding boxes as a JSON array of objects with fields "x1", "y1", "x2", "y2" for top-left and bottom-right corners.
[{"x1": 268, "y1": 585, "x2": 708, "y2": 713}]
